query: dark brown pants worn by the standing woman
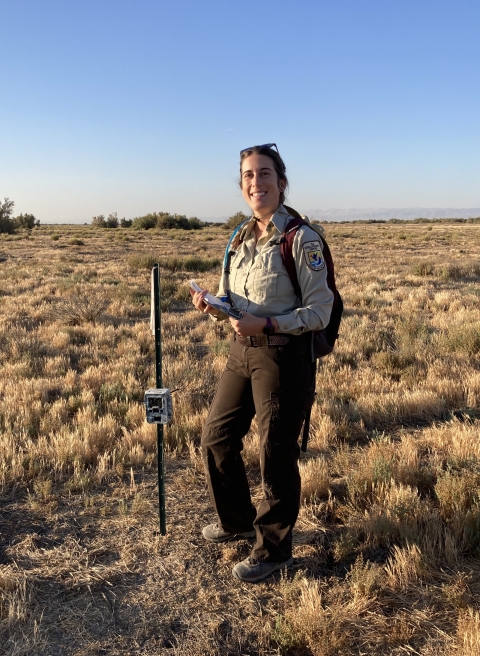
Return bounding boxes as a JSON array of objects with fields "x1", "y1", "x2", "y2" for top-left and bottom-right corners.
[{"x1": 202, "y1": 333, "x2": 315, "y2": 562}]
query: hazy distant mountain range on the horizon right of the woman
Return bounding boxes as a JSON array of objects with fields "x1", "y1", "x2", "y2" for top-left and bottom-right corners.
[{"x1": 303, "y1": 207, "x2": 480, "y2": 221}]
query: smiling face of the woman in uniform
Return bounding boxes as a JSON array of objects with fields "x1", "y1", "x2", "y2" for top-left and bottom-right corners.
[{"x1": 242, "y1": 154, "x2": 286, "y2": 216}]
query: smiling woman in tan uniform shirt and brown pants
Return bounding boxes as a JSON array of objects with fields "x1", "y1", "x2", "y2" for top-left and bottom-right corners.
[{"x1": 193, "y1": 144, "x2": 333, "y2": 583}]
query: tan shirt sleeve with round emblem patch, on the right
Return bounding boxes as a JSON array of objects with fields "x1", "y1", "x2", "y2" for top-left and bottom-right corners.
[{"x1": 275, "y1": 226, "x2": 333, "y2": 335}]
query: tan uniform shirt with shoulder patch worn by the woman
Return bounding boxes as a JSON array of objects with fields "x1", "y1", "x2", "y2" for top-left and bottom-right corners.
[{"x1": 218, "y1": 205, "x2": 333, "y2": 335}]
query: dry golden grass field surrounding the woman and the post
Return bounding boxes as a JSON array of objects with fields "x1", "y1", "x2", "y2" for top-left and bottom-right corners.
[{"x1": 0, "y1": 224, "x2": 480, "y2": 656}]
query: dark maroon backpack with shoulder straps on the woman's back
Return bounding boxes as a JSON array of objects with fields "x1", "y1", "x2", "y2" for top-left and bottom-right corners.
[{"x1": 223, "y1": 205, "x2": 343, "y2": 358}]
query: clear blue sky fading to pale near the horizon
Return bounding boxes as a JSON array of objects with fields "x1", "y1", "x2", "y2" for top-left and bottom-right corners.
[{"x1": 0, "y1": 0, "x2": 480, "y2": 223}]
